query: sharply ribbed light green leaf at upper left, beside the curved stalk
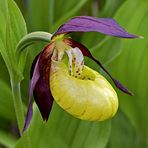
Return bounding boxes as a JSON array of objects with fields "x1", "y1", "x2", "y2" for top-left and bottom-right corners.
[{"x1": 0, "y1": 0, "x2": 27, "y2": 79}]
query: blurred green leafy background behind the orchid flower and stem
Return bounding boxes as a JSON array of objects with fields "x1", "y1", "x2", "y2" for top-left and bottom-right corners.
[{"x1": 0, "y1": 0, "x2": 148, "y2": 148}]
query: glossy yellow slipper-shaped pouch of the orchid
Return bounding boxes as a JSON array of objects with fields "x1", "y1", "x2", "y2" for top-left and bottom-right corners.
[{"x1": 50, "y1": 60, "x2": 118, "y2": 121}]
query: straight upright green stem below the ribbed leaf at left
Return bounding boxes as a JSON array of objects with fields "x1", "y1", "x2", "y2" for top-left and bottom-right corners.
[{"x1": 11, "y1": 78, "x2": 24, "y2": 136}]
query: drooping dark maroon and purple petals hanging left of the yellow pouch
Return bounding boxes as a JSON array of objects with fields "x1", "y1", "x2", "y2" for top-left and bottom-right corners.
[{"x1": 23, "y1": 44, "x2": 53, "y2": 131}]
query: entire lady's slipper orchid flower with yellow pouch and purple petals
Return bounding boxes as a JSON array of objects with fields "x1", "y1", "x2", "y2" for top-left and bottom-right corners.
[{"x1": 24, "y1": 16, "x2": 138, "y2": 130}]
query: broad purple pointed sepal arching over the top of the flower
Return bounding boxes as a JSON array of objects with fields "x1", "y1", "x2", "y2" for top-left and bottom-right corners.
[{"x1": 53, "y1": 16, "x2": 138, "y2": 38}]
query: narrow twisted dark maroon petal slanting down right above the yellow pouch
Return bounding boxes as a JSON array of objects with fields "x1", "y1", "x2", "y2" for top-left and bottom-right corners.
[{"x1": 63, "y1": 38, "x2": 132, "y2": 95}]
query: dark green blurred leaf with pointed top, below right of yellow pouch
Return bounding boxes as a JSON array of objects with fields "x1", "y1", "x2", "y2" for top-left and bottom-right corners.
[{"x1": 107, "y1": 110, "x2": 139, "y2": 148}]
